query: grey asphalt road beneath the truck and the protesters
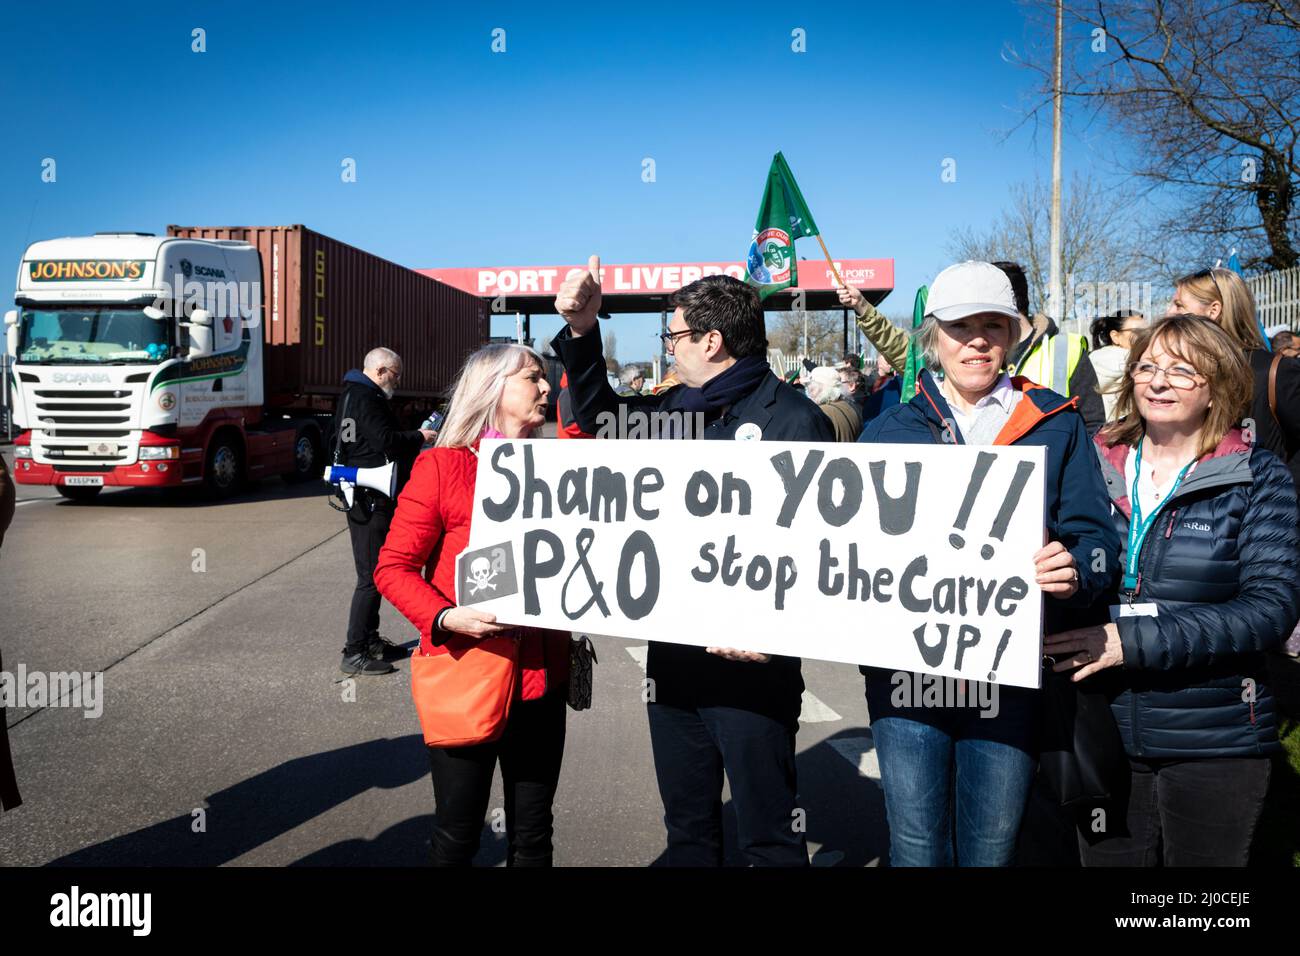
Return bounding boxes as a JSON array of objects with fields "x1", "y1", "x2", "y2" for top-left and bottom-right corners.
[{"x1": 0, "y1": 449, "x2": 888, "y2": 866}]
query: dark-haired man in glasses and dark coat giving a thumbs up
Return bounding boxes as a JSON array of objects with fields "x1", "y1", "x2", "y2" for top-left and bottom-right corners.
[{"x1": 551, "y1": 256, "x2": 835, "y2": 866}]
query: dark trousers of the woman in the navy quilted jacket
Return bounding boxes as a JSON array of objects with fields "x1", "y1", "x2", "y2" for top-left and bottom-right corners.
[{"x1": 1079, "y1": 757, "x2": 1271, "y2": 866}]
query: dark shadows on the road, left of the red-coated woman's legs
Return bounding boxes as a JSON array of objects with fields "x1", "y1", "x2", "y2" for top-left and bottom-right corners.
[{"x1": 49, "y1": 734, "x2": 426, "y2": 866}]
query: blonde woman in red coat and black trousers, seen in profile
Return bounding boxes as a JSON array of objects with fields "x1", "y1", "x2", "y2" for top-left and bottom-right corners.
[{"x1": 374, "y1": 345, "x2": 569, "y2": 866}]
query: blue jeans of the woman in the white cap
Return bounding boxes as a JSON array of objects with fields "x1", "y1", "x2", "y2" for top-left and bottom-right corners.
[{"x1": 867, "y1": 674, "x2": 1037, "y2": 866}]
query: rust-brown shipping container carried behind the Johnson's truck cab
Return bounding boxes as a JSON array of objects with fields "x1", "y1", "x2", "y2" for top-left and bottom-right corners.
[{"x1": 166, "y1": 225, "x2": 489, "y2": 406}]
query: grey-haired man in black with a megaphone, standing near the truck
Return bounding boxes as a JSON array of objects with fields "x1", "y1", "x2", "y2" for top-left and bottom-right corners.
[{"x1": 334, "y1": 349, "x2": 434, "y2": 676}]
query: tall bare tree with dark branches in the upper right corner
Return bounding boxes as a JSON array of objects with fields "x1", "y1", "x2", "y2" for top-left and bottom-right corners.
[{"x1": 1017, "y1": 0, "x2": 1300, "y2": 269}]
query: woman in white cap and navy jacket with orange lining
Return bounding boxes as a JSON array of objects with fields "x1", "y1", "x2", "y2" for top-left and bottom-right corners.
[{"x1": 859, "y1": 261, "x2": 1119, "y2": 866}]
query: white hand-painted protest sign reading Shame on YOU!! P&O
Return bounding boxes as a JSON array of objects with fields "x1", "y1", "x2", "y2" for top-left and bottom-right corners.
[{"x1": 456, "y1": 440, "x2": 1044, "y2": 687}]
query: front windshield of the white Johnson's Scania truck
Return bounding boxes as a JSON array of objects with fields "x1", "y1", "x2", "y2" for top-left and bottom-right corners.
[{"x1": 18, "y1": 306, "x2": 172, "y2": 365}]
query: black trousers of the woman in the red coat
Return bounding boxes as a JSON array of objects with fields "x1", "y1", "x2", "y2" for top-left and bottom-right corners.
[{"x1": 428, "y1": 688, "x2": 568, "y2": 866}]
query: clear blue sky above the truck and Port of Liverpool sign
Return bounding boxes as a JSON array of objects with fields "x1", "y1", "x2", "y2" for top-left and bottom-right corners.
[{"x1": 0, "y1": 0, "x2": 1128, "y2": 360}]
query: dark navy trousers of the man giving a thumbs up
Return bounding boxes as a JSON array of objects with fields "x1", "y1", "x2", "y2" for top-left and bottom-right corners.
[{"x1": 649, "y1": 704, "x2": 809, "y2": 866}]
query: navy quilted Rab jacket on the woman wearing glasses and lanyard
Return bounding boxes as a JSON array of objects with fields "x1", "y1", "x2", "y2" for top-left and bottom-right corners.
[{"x1": 1097, "y1": 429, "x2": 1300, "y2": 758}]
